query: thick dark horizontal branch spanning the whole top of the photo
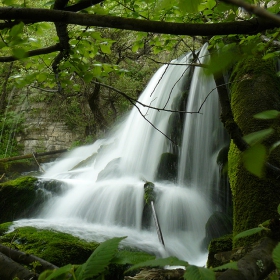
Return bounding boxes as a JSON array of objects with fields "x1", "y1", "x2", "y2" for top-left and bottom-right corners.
[{"x1": 0, "y1": 7, "x2": 280, "y2": 36}]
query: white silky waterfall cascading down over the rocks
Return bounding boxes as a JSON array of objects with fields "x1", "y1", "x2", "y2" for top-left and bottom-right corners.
[{"x1": 12, "y1": 45, "x2": 229, "y2": 264}]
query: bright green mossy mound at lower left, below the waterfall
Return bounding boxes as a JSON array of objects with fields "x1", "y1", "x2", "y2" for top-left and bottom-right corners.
[{"x1": 0, "y1": 227, "x2": 98, "y2": 267}]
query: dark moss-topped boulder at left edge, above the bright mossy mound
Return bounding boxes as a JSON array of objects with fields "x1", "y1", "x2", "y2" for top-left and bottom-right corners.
[{"x1": 0, "y1": 177, "x2": 37, "y2": 223}]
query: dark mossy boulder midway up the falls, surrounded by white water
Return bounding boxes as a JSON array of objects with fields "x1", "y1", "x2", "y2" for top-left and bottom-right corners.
[{"x1": 156, "y1": 153, "x2": 178, "y2": 182}]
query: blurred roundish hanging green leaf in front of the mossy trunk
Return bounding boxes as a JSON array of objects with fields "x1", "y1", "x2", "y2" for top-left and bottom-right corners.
[{"x1": 243, "y1": 144, "x2": 267, "y2": 177}]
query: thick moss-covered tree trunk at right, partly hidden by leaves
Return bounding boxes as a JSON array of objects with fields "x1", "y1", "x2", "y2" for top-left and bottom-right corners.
[{"x1": 228, "y1": 57, "x2": 280, "y2": 246}]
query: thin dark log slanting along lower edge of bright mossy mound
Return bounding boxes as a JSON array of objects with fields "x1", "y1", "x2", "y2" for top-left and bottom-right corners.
[{"x1": 0, "y1": 244, "x2": 58, "y2": 272}]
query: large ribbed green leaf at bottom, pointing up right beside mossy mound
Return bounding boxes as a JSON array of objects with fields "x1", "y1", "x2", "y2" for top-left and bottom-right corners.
[{"x1": 77, "y1": 237, "x2": 125, "y2": 280}]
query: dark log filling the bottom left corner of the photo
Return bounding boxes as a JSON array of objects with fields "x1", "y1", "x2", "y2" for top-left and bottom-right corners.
[{"x1": 0, "y1": 253, "x2": 38, "y2": 280}]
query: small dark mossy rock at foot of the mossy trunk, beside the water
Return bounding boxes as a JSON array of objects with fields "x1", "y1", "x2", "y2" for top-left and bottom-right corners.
[{"x1": 207, "y1": 234, "x2": 232, "y2": 267}]
